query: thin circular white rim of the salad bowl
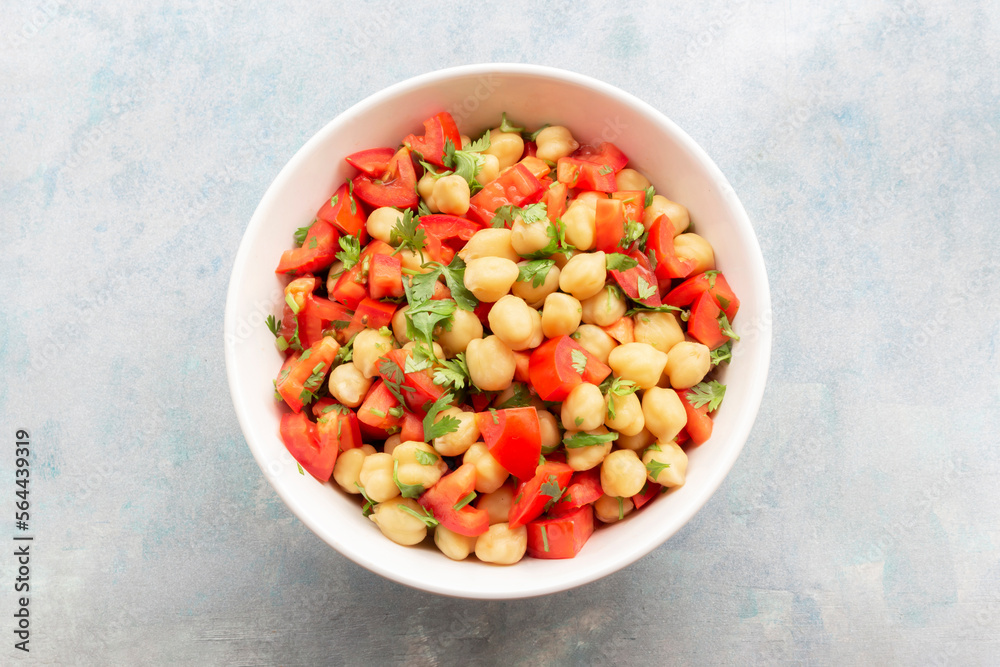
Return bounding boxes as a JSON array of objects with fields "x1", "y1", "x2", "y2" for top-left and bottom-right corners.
[{"x1": 223, "y1": 63, "x2": 772, "y2": 599}]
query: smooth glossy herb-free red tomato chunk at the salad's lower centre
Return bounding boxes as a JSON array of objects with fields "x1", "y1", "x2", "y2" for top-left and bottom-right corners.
[{"x1": 476, "y1": 407, "x2": 542, "y2": 479}]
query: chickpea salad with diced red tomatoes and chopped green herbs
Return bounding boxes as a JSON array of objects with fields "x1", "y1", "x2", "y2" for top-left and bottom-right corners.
[{"x1": 267, "y1": 112, "x2": 740, "y2": 565}]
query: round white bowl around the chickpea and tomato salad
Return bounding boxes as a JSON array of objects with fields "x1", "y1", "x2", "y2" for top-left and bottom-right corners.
[{"x1": 225, "y1": 64, "x2": 771, "y2": 599}]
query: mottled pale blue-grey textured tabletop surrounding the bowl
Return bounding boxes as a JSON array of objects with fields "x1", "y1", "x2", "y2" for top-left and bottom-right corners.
[{"x1": 0, "y1": 0, "x2": 1000, "y2": 664}]
